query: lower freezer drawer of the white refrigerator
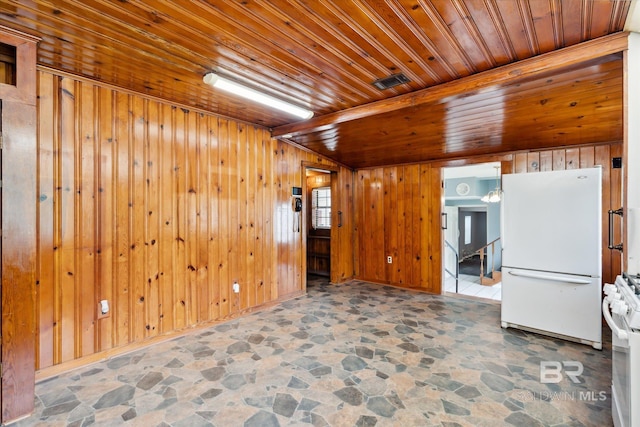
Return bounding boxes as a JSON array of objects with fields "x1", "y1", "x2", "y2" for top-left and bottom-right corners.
[{"x1": 501, "y1": 268, "x2": 602, "y2": 344}]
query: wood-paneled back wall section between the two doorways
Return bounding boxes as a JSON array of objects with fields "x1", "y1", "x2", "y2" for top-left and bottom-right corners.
[{"x1": 355, "y1": 164, "x2": 442, "y2": 293}]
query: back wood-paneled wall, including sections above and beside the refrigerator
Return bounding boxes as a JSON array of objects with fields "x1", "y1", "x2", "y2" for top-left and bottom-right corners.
[{"x1": 355, "y1": 143, "x2": 622, "y2": 293}]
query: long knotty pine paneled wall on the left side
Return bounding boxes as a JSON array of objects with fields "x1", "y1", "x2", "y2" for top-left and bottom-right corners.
[{"x1": 36, "y1": 71, "x2": 344, "y2": 369}]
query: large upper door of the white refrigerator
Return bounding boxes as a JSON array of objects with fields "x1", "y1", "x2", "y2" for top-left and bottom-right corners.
[{"x1": 501, "y1": 167, "x2": 602, "y2": 276}]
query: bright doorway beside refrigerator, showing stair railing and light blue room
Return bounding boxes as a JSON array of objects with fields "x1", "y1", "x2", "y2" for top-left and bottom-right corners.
[{"x1": 442, "y1": 162, "x2": 502, "y2": 301}]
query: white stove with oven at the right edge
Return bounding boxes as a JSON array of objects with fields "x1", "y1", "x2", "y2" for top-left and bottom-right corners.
[{"x1": 602, "y1": 276, "x2": 640, "y2": 427}]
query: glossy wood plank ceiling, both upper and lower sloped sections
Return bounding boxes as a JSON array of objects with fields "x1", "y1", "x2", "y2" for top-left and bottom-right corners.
[{"x1": 0, "y1": 0, "x2": 631, "y2": 168}]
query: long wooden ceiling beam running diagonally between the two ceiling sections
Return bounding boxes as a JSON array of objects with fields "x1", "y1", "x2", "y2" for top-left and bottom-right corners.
[{"x1": 273, "y1": 32, "x2": 628, "y2": 136}]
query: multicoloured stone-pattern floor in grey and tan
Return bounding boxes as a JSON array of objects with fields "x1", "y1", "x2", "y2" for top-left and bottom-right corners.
[{"x1": 14, "y1": 281, "x2": 611, "y2": 427}]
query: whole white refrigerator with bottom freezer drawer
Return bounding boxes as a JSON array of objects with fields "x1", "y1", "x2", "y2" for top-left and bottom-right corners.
[{"x1": 501, "y1": 167, "x2": 602, "y2": 349}]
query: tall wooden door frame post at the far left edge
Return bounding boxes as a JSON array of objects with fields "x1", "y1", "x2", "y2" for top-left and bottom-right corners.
[{"x1": 0, "y1": 26, "x2": 39, "y2": 424}]
